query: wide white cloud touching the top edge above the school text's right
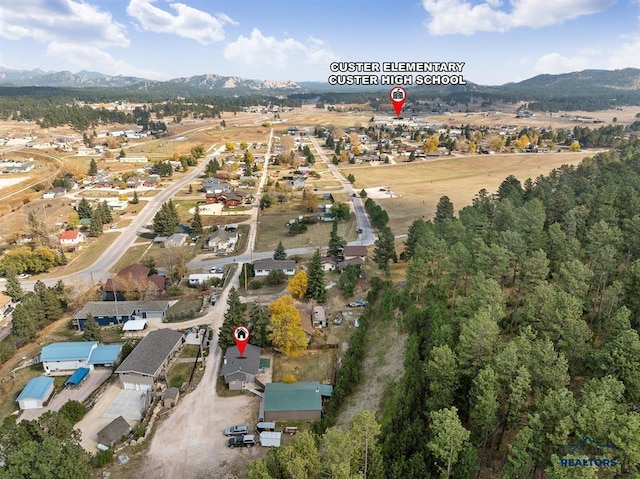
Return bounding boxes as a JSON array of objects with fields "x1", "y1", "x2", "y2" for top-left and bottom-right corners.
[{"x1": 422, "y1": 0, "x2": 616, "y2": 35}]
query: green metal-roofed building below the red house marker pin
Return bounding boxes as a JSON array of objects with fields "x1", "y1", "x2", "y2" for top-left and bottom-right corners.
[{"x1": 260, "y1": 381, "x2": 333, "y2": 421}]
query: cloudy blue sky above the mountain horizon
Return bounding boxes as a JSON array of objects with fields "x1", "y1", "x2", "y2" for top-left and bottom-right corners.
[{"x1": 0, "y1": 0, "x2": 640, "y2": 85}]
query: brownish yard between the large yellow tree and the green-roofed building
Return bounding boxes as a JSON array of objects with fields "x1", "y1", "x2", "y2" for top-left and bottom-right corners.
[{"x1": 273, "y1": 349, "x2": 336, "y2": 384}]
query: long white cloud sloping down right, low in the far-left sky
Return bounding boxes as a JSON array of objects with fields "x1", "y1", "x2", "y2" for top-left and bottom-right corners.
[{"x1": 46, "y1": 42, "x2": 167, "y2": 79}]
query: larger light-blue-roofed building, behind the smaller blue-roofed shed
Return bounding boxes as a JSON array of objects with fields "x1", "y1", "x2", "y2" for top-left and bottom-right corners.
[{"x1": 40, "y1": 341, "x2": 122, "y2": 376}]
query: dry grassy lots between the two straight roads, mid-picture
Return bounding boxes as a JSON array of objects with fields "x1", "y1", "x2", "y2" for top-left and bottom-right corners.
[{"x1": 255, "y1": 201, "x2": 357, "y2": 251}]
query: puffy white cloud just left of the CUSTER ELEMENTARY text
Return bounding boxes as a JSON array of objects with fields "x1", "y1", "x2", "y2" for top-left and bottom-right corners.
[{"x1": 224, "y1": 28, "x2": 337, "y2": 68}]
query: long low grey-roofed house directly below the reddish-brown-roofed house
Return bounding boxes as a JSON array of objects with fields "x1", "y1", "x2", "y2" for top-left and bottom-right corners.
[{"x1": 73, "y1": 301, "x2": 169, "y2": 331}]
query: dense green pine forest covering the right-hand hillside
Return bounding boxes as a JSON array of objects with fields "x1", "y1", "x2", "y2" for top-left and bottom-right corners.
[{"x1": 249, "y1": 140, "x2": 640, "y2": 479}]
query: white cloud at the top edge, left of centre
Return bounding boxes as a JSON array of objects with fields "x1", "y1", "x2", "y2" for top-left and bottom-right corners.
[{"x1": 127, "y1": 0, "x2": 237, "y2": 45}]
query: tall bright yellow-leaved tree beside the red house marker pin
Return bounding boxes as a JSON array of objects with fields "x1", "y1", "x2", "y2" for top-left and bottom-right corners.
[{"x1": 268, "y1": 294, "x2": 307, "y2": 356}]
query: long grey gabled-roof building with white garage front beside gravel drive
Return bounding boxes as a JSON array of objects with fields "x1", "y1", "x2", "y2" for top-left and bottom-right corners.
[{"x1": 116, "y1": 329, "x2": 184, "y2": 391}]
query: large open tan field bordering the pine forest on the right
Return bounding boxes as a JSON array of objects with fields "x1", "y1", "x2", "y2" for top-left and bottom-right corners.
[{"x1": 340, "y1": 152, "x2": 589, "y2": 234}]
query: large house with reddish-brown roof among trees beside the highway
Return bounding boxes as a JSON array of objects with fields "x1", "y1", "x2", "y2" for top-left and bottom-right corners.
[{"x1": 102, "y1": 263, "x2": 167, "y2": 301}]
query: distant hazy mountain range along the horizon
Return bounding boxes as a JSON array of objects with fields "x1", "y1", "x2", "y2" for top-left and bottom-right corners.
[{"x1": 0, "y1": 67, "x2": 640, "y2": 96}]
